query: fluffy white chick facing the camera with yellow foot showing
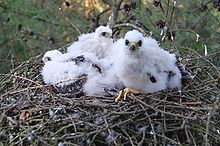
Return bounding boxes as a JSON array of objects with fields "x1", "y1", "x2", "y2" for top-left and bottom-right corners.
[{"x1": 112, "y1": 30, "x2": 181, "y2": 101}]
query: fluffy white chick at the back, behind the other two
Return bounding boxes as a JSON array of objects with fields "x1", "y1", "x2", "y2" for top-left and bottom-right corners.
[{"x1": 67, "y1": 26, "x2": 113, "y2": 58}]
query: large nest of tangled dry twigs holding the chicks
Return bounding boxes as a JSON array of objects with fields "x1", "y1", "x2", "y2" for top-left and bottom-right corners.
[{"x1": 0, "y1": 50, "x2": 220, "y2": 146}]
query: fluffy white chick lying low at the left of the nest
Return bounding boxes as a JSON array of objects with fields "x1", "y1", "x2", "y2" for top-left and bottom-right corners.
[{"x1": 41, "y1": 50, "x2": 117, "y2": 96}]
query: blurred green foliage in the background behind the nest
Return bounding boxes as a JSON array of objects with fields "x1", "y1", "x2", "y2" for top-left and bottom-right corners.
[{"x1": 0, "y1": 0, "x2": 220, "y2": 73}]
